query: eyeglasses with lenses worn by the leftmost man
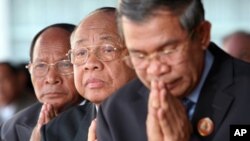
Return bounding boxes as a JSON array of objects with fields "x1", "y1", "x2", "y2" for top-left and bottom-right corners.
[{"x1": 26, "y1": 60, "x2": 73, "y2": 77}]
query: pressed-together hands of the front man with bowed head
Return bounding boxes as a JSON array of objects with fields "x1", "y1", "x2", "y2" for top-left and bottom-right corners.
[{"x1": 146, "y1": 80, "x2": 192, "y2": 141}]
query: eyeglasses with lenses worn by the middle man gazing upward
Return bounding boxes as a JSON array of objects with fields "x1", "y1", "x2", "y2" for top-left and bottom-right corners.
[{"x1": 67, "y1": 44, "x2": 124, "y2": 65}]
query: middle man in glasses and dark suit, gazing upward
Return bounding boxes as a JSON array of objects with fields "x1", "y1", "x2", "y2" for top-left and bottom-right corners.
[{"x1": 39, "y1": 7, "x2": 135, "y2": 141}]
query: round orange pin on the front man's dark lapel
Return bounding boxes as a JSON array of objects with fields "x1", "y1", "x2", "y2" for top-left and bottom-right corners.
[{"x1": 198, "y1": 117, "x2": 214, "y2": 137}]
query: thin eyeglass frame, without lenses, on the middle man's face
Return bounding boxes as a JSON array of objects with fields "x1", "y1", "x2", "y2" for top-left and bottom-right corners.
[{"x1": 66, "y1": 43, "x2": 126, "y2": 65}]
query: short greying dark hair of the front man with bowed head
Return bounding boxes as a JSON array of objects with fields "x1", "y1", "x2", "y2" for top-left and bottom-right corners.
[{"x1": 118, "y1": 0, "x2": 205, "y2": 32}]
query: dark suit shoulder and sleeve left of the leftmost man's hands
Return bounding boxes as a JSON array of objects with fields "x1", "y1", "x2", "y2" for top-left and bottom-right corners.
[{"x1": 1, "y1": 102, "x2": 42, "y2": 141}]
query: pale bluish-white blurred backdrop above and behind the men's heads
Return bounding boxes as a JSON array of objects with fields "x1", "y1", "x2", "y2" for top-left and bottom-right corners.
[{"x1": 0, "y1": 0, "x2": 250, "y2": 64}]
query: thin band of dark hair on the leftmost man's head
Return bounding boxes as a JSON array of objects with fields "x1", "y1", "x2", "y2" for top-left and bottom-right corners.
[{"x1": 30, "y1": 23, "x2": 76, "y2": 62}]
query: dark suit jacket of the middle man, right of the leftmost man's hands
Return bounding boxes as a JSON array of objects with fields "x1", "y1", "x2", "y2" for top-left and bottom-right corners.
[{"x1": 41, "y1": 102, "x2": 95, "y2": 141}]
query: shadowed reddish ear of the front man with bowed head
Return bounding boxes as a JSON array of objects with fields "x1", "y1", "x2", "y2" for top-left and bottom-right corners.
[{"x1": 197, "y1": 21, "x2": 211, "y2": 50}]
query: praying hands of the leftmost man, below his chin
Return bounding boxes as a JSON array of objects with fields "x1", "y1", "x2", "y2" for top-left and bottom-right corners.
[{"x1": 30, "y1": 103, "x2": 58, "y2": 141}]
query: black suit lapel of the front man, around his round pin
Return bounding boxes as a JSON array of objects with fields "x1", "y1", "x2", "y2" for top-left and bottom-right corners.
[{"x1": 192, "y1": 44, "x2": 234, "y2": 139}]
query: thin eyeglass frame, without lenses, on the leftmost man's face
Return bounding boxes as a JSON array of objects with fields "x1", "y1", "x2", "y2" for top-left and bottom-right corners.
[{"x1": 25, "y1": 59, "x2": 74, "y2": 77}]
